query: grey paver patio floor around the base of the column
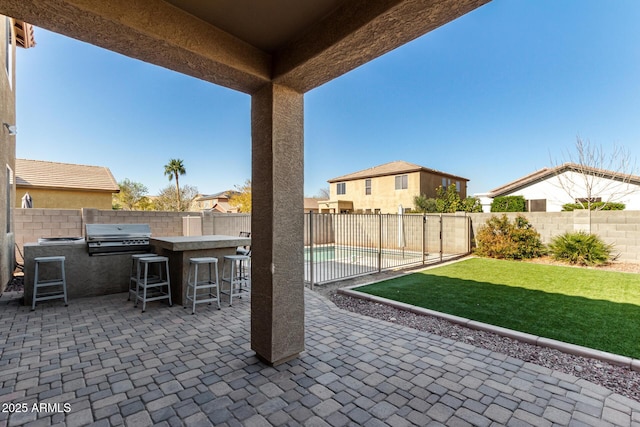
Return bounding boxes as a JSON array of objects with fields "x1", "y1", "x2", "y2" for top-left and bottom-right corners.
[{"x1": 0, "y1": 290, "x2": 640, "y2": 427}]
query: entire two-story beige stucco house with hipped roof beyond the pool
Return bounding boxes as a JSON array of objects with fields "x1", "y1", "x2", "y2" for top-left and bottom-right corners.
[{"x1": 319, "y1": 161, "x2": 469, "y2": 213}]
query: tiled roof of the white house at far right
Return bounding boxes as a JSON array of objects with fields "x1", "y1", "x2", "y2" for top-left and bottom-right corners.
[{"x1": 487, "y1": 163, "x2": 640, "y2": 197}]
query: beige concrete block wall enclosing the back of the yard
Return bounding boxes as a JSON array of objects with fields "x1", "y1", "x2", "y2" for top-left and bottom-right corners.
[{"x1": 13, "y1": 209, "x2": 640, "y2": 263}]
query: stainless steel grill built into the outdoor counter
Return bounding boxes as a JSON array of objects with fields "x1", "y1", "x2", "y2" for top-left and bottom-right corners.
[{"x1": 85, "y1": 224, "x2": 151, "y2": 255}]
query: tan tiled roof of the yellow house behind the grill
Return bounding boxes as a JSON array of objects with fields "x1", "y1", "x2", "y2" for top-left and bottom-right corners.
[{"x1": 16, "y1": 159, "x2": 120, "y2": 193}]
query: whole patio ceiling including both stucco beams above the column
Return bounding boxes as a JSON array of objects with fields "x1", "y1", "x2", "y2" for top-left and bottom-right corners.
[{"x1": 0, "y1": 0, "x2": 490, "y2": 94}]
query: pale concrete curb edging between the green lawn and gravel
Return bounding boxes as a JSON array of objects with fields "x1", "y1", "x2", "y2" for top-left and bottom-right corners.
[{"x1": 337, "y1": 285, "x2": 640, "y2": 372}]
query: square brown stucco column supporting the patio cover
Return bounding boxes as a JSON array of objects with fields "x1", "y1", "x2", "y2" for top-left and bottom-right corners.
[{"x1": 251, "y1": 84, "x2": 304, "y2": 365}]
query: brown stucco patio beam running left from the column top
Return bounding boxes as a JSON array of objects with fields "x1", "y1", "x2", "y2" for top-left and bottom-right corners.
[{"x1": 0, "y1": 0, "x2": 271, "y2": 93}]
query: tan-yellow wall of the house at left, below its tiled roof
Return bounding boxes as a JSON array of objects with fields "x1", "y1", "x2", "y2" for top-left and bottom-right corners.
[{"x1": 14, "y1": 187, "x2": 112, "y2": 209}]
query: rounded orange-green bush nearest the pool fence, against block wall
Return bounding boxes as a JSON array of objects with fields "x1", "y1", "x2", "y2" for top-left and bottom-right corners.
[{"x1": 475, "y1": 215, "x2": 544, "y2": 259}]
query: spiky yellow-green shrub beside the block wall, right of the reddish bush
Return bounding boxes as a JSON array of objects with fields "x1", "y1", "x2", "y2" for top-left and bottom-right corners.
[{"x1": 549, "y1": 231, "x2": 613, "y2": 265}]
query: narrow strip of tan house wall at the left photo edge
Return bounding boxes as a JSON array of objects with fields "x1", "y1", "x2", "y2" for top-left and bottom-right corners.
[{"x1": 0, "y1": 15, "x2": 16, "y2": 293}]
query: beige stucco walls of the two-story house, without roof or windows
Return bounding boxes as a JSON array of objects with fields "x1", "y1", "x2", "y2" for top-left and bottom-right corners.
[{"x1": 329, "y1": 171, "x2": 467, "y2": 214}]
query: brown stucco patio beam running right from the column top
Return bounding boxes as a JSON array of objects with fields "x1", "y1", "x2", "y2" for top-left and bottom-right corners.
[{"x1": 273, "y1": 0, "x2": 490, "y2": 93}]
